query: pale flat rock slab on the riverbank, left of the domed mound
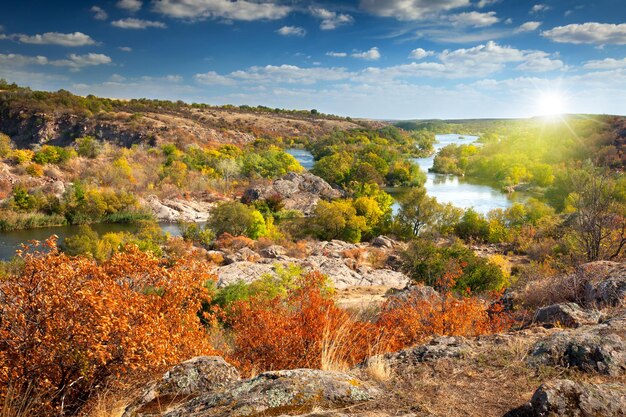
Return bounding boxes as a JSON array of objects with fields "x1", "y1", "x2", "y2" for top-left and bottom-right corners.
[{"x1": 141, "y1": 195, "x2": 215, "y2": 223}]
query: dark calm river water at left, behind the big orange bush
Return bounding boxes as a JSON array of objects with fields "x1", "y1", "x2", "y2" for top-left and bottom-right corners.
[{"x1": 0, "y1": 223, "x2": 186, "y2": 260}]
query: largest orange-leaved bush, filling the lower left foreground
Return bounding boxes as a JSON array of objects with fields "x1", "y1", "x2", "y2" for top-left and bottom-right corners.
[{"x1": 0, "y1": 239, "x2": 214, "y2": 414}]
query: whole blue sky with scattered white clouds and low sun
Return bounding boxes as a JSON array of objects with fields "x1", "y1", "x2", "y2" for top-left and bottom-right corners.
[{"x1": 0, "y1": 0, "x2": 626, "y2": 119}]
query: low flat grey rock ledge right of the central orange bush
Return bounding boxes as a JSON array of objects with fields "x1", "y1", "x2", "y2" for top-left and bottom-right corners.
[{"x1": 384, "y1": 336, "x2": 469, "y2": 366}]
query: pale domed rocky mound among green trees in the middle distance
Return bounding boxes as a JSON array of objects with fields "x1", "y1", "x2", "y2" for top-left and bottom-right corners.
[{"x1": 242, "y1": 172, "x2": 342, "y2": 215}]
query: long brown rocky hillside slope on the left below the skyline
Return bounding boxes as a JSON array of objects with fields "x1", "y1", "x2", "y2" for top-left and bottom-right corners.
[{"x1": 0, "y1": 92, "x2": 382, "y2": 147}]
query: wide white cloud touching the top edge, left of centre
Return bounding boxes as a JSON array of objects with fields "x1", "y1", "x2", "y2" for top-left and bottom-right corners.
[{"x1": 153, "y1": 0, "x2": 292, "y2": 21}]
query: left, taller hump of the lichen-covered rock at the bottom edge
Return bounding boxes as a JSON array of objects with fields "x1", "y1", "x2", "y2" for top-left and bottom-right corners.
[{"x1": 123, "y1": 356, "x2": 240, "y2": 417}]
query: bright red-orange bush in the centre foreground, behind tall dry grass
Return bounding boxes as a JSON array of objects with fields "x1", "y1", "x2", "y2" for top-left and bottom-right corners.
[{"x1": 230, "y1": 272, "x2": 371, "y2": 373}]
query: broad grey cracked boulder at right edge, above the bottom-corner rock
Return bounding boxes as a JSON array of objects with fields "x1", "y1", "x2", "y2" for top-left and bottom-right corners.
[{"x1": 527, "y1": 316, "x2": 626, "y2": 375}]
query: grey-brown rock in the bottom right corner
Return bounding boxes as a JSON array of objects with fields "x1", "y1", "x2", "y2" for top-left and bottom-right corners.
[{"x1": 505, "y1": 379, "x2": 626, "y2": 417}]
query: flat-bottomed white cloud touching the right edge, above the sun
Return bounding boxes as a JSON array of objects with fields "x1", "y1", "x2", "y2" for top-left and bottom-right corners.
[{"x1": 541, "y1": 22, "x2": 626, "y2": 45}]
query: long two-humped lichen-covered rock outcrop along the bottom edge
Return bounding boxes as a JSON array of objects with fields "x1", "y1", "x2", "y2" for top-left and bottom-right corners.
[{"x1": 124, "y1": 357, "x2": 381, "y2": 417}]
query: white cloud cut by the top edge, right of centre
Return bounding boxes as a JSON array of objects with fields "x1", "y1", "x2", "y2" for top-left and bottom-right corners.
[{"x1": 360, "y1": 0, "x2": 470, "y2": 20}]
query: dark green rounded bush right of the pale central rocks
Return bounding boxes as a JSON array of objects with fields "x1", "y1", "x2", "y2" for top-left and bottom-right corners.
[{"x1": 402, "y1": 239, "x2": 507, "y2": 292}]
